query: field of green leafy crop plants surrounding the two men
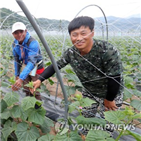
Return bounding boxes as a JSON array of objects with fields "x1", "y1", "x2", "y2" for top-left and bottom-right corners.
[{"x1": 0, "y1": 35, "x2": 141, "y2": 141}]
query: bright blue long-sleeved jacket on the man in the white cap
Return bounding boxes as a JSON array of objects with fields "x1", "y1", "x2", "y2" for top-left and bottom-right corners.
[{"x1": 12, "y1": 32, "x2": 42, "y2": 80}]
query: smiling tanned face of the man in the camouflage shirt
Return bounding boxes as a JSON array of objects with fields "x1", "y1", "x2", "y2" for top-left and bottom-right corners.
[{"x1": 70, "y1": 26, "x2": 94, "y2": 51}]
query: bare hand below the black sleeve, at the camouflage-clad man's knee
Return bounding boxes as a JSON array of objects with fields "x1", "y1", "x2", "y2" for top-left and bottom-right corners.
[{"x1": 104, "y1": 99, "x2": 118, "y2": 111}]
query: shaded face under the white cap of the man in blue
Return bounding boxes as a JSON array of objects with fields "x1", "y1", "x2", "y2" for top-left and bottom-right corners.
[{"x1": 13, "y1": 30, "x2": 27, "y2": 43}]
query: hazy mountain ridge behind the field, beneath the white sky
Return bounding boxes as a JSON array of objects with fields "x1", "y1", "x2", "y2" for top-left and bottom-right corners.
[{"x1": 0, "y1": 8, "x2": 141, "y2": 31}]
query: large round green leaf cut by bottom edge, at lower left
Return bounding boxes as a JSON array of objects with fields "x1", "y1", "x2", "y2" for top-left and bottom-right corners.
[{"x1": 15, "y1": 122, "x2": 40, "y2": 141}]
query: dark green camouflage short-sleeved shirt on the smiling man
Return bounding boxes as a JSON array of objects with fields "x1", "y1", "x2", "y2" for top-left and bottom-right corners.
[{"x1": 57, "y1": 39, "x2": 122, "y2": 98}]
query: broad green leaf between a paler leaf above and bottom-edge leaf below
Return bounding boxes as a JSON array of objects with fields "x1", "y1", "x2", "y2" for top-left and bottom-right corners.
[{"x1": 28, "y1": 107, "x2": 46, "y2": 125}]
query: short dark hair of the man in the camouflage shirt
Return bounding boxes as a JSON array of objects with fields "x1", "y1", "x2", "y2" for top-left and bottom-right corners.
[{"x1": 68, "y1": 16, "x2": 94, "y2": 34}]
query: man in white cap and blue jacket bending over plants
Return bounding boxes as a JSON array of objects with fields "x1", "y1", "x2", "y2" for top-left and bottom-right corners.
[{"x1": 12, "y1": 22, "x2": 44, "y2": 104}]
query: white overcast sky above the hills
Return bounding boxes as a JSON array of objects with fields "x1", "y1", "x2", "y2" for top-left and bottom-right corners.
[{"x1": 0, "y1": 0, "x2": 141, "y2": 21}]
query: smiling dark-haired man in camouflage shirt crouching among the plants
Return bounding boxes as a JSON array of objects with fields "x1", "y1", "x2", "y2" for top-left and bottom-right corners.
[{"x1": 34, "y1": 16, "x2": 123, "y2": 117}]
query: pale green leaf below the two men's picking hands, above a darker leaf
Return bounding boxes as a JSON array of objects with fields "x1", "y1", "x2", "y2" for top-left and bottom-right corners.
[{"x1": 21, "y1": 96, "x2": 37, "y2": 111}]
